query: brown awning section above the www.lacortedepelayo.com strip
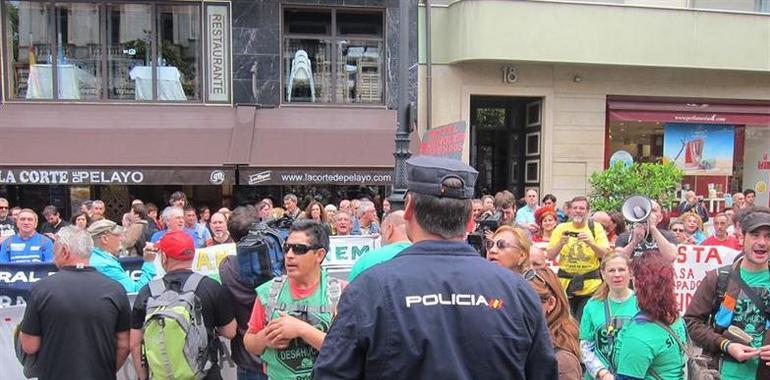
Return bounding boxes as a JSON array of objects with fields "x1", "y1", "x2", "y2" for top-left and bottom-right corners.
[{"x1": 249, "y1": 107, "x2": 402, "y2": 168}]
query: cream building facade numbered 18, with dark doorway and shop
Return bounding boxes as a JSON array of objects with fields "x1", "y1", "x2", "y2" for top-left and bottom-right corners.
[{"x1": 419, "y1": 0, "x2": 770, "y2": 211}]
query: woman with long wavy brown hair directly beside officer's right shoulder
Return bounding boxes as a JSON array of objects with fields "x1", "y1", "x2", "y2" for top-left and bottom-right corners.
[{"x1": 529, "y1": 268, "x2": 582, "y2": 380}]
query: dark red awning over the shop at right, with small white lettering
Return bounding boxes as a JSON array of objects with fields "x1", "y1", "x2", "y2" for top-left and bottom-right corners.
[{"x1": 607, "y1": 100, "x2": 770, "y2": 125}]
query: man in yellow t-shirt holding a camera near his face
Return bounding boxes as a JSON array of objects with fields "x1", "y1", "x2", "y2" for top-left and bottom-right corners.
[{"x1": 547, "y1": 196, "x2": 610, "y2": 320}]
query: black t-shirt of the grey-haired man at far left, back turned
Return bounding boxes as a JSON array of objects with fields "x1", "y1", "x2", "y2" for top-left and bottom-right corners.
[{"x1": 21, "y1": 267, "x2": 130, "y2": 380}]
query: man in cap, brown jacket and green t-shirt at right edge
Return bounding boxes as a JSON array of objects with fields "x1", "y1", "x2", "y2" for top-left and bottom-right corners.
[{"x1": 684, "y1": 207, "x2": 770, "y2": 380}]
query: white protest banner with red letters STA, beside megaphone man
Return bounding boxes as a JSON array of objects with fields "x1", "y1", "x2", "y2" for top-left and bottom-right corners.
[{"x1": 674, "y1": 245, "x2": 741, "y2": 314}]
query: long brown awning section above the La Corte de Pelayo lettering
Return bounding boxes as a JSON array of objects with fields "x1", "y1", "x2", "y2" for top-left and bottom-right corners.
[{"x1": 0, "y1": 103, "x2": 244, "y2": 167}]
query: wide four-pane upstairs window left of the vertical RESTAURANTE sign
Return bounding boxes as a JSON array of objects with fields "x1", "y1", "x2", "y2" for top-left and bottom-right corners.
[{"x1": 0, "y1": 0, "x2": 210, "y2": 102}]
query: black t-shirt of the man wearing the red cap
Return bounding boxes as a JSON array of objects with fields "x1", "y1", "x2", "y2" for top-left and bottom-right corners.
[{"x1": 131, "y1": 270, "x2": 234, "y2": 379}]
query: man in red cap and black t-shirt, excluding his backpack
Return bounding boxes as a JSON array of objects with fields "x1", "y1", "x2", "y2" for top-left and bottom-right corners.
[{"x1": 131, "y1": 231, "x2": 237, "y2": 379}]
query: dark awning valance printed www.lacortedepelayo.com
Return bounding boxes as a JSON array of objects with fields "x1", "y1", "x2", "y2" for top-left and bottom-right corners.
[{"x1": 238, "y1": 167, "x2": 393, "y2": 185}]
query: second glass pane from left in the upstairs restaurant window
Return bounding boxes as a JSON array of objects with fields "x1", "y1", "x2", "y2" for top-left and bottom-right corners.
[{"x1": 56, "y1": 3, "x2": 102, "y2": 100}]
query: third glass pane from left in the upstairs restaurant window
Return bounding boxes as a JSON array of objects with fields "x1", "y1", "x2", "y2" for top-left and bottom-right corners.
[{"x1": 107, "y1": 4, "x2": 152, "y2": 100}]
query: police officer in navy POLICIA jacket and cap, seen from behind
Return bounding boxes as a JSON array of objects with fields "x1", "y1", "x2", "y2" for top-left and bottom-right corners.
[{"x1": 314, "y1": 156, "x2": 558, "y2": 379}]
